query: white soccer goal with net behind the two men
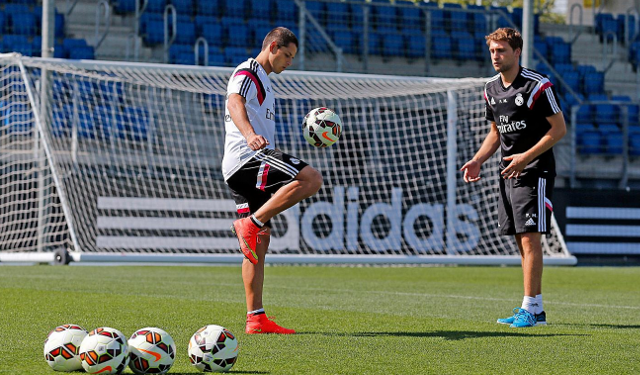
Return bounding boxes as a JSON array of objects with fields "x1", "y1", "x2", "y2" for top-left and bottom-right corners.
[{"x1": 0, "y1": 55, "x2": 575, "y2": 264}]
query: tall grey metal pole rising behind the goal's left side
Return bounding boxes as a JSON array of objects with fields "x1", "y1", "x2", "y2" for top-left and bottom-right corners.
[{"x1": 36, "y1": 0, "x2": 56, "y2": 252}]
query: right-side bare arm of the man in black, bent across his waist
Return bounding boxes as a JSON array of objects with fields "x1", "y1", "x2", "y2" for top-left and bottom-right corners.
[{"x1": 501, "y1": 112, "x2": 567, "y2": 178}]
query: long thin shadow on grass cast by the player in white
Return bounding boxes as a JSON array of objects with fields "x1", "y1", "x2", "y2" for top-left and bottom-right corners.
[{"x1": 299, "y1": 331, "x2": 587, "y2": 340}]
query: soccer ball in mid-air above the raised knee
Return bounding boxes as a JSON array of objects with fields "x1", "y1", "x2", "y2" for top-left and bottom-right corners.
[{"x1": 302, "y1": 107, "x2": 342, "y2": 148}]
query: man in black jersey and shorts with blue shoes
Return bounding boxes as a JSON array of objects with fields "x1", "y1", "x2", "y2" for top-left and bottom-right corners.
[{"x1": 461, "y1": 28, "x2": 567, "y2": 327}]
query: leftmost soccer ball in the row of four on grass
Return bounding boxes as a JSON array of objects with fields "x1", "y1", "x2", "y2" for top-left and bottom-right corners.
[{"x1": 44, "y1": 324, "x2": 87, "y2": 371}]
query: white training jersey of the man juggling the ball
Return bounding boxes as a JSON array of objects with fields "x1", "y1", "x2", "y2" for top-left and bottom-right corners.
[{"x1": 222, "y1": 58, "x2": 276, "y2": 181}]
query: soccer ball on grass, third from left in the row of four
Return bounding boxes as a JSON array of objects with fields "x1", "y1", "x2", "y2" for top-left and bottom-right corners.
[{"x1": 129, "y1": 327, "x2": 176, "y2": 374}]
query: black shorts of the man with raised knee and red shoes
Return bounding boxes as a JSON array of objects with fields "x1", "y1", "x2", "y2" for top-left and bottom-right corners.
[{"x1": 226, "y1": 149, "x2": 308, "y2": 227}]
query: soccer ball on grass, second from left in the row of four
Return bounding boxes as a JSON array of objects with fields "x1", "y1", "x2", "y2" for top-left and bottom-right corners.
[{"x1": 80, "y1": 327, "x2": 129, "y2": 374}]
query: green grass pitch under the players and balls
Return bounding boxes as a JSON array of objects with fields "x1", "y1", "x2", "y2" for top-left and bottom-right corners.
[{"x1": 0, "y1": 266, "x2": 640, "y2": 375}]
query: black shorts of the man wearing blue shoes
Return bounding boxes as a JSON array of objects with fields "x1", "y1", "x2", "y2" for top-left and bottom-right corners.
[{"x1": 498, "y1": 173, "x2": 554, "y2": 235}]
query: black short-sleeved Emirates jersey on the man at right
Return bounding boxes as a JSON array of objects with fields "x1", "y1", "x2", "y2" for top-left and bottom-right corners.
[{"x1": 484, "y1": 67, "x2": 560, "y2": 176}]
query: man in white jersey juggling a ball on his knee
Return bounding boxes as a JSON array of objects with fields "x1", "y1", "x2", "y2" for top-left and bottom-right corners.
[{"x1": 222, "y1": 27, "x2": 322, "y2": 334}]
